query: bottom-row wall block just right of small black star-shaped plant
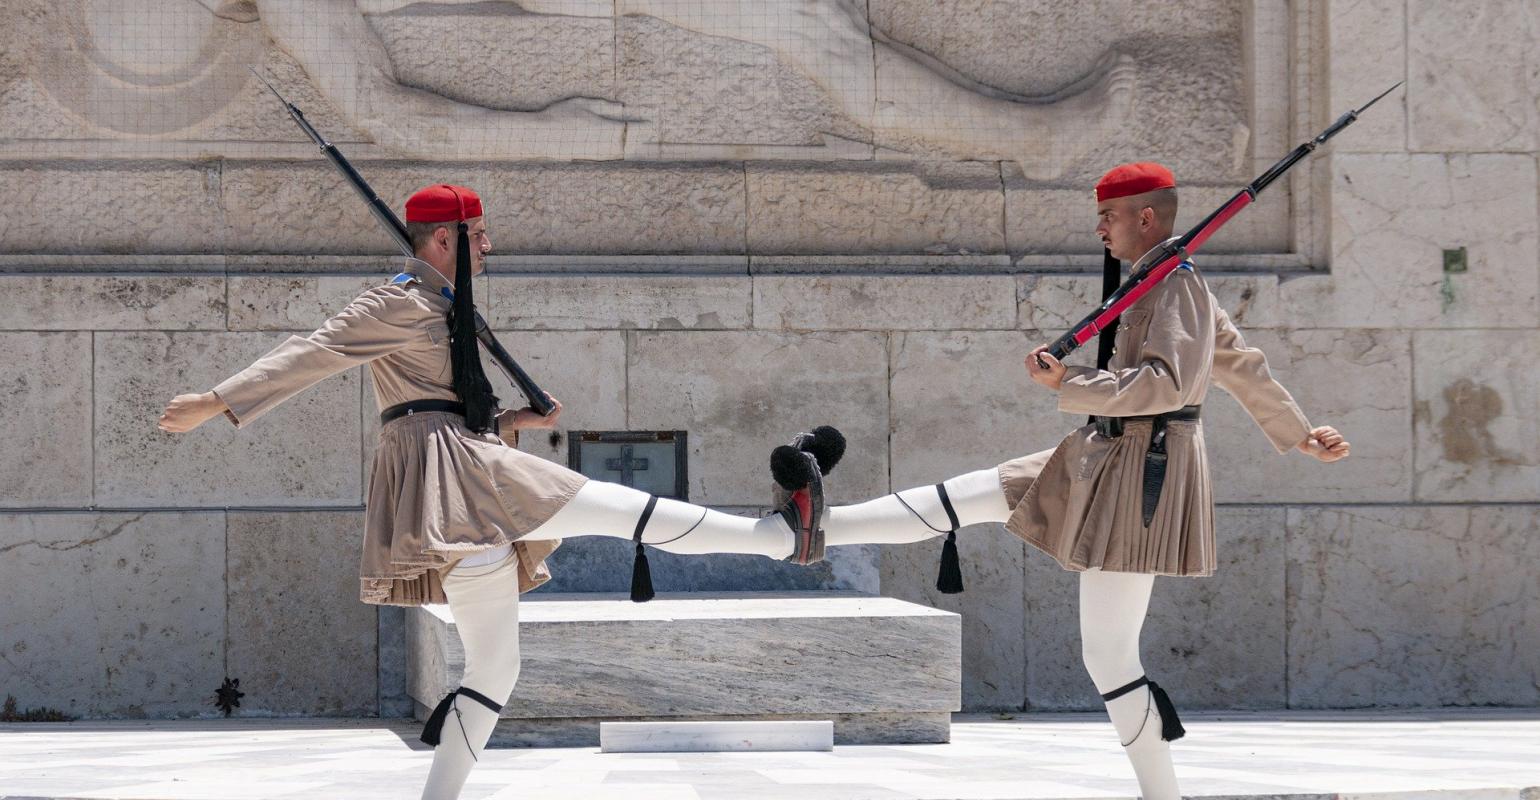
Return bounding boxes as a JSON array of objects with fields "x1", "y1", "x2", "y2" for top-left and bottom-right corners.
[{"x1": 225, "y1": 512, "x2": 379, "y2": 717}]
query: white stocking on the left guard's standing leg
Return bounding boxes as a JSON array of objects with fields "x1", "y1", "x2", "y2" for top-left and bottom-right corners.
[{"x1": 422, "y1": 556, "x2": 519, "y2": 800}]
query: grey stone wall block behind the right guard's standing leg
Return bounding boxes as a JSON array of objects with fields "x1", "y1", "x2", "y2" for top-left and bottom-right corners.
[{"x1": 1026, "y1": 506, "x2": 1294, "y2": 709}]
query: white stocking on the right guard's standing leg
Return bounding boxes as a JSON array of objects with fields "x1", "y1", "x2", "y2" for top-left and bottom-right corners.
[{"x1": 1080, "y1": 569, "x2": 1181, "y2": 800}]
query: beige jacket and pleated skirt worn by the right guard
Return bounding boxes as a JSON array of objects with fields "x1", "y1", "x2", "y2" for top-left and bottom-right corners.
[{"x1": 999, "y1": 257, "x2": 1311, "y2": 575}]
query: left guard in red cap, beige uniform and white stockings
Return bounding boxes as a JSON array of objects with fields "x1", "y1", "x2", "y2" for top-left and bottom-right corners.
[{"x1": 160, "y1": 185, "x2": 807, "y2": 798}]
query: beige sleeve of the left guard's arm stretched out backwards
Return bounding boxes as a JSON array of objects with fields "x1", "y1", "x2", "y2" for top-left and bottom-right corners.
[{"x1": 214, "y1": 287, "x2": 422, "y2": 427}]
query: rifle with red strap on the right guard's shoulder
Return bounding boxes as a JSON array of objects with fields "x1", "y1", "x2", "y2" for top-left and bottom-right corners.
[{"x1": 1038, "y1": 83, "x2": 1401, "y2": 368}]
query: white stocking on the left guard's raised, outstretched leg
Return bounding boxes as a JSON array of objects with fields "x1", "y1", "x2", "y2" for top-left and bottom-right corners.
[{"x1": 524, "y1": 481, "x2": 792, "y2": 558}]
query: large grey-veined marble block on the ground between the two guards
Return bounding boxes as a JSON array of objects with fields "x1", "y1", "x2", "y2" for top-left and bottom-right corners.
[{"x1": 407, "y1": 592, "x2": 961, "y2": 745}]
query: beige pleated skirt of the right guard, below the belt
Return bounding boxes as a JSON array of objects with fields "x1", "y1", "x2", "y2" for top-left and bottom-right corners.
[{"x1": 999, "y1": 421, "x2": 1217, "y2": 576}]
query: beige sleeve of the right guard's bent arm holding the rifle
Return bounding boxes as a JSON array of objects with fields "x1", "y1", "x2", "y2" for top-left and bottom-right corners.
[{"x1": 1060, "y1": 270, "x2": 1214, "y2": 416}]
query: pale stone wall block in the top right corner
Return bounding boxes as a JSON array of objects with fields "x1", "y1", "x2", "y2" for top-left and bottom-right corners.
[{"x1": 1406, "y1": 0, "x2": 1540, "y2": 153}]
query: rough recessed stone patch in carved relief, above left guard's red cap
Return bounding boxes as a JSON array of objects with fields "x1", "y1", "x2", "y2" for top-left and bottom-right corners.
[{"x1": 368, "y1": 3, "x2": 616, "y2": 111}]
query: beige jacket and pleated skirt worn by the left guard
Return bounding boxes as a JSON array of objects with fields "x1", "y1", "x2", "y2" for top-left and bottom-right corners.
[{"x1": 214, "y1": 259, "x2": 585, "y2": 606}]
